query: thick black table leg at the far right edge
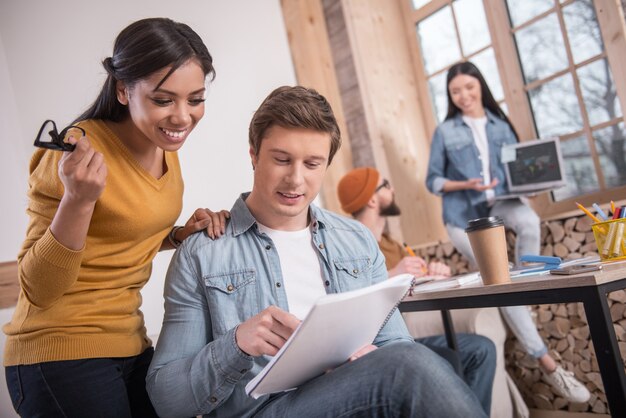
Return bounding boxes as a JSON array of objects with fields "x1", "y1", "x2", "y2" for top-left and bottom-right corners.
[{"x1": 583, "y1": 288, "x2": 626, "y2": 417}]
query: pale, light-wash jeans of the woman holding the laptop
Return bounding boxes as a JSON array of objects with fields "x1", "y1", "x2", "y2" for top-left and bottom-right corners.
[{"x1": 446, "y1": 199, "x2": 548, "y2": 359}]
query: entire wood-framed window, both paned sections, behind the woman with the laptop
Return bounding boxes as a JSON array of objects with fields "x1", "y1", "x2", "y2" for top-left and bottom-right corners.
[{"x1": 399, "y1": 0, "x2": 626, "y2": 215}]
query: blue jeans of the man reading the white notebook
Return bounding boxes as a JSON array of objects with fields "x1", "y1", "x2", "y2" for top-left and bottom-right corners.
[{"x1": 255, "y1": 342, "x2": 487, "y2": 418}]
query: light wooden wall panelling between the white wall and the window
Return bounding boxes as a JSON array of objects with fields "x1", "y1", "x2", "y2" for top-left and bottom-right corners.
[{"x1": 282, "y1": 0, "x2": 447, "y2": 245}]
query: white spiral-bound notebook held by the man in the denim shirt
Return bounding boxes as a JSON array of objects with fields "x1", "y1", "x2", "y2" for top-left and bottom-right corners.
[{"x1": 246, "y1": 274, "x2": 413, "y2": 399}]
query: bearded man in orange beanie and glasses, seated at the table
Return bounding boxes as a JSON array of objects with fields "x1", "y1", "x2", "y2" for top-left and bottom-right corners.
[{"x1": 337, "y1": 167, "x2": 496, "y2": 414}]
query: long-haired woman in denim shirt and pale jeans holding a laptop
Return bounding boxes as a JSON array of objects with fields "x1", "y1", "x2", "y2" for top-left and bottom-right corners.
[{"x1": 426, "y1": 62, "x2": 590, "y2": 402}]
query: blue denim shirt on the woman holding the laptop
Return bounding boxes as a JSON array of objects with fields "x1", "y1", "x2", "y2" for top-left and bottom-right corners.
[{"x1": 426, "y1": 109, "x2": 517, "y2": 228}]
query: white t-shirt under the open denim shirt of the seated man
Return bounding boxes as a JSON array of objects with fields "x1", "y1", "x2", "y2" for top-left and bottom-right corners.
[{"x1": 258, "y1": 224, "x2": 326, "y2": 319}]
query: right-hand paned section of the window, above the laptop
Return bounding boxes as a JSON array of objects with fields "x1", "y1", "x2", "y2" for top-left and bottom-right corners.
[{"x1": 506, "y1": 0, "x2": 626, "y2": 201}]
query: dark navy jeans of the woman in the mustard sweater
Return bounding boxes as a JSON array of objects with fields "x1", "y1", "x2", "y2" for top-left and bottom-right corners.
[{"x1": 5, "y1": 348, "x2": 157, "y2": 418}]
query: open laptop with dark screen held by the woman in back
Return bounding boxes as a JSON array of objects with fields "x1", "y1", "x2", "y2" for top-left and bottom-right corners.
[{"x1": 495, "y1": 138, "x2": 566, "y2": 200}]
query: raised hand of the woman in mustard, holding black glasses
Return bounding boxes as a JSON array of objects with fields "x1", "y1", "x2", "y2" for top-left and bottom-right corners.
[{"x1": 58, "y1": 137, "x2": 107, "y2": 204}]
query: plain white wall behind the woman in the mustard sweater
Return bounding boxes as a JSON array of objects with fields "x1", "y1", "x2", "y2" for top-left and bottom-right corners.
[{"x1": 0, "y1": 0, "x2": 295, "y2": 417}]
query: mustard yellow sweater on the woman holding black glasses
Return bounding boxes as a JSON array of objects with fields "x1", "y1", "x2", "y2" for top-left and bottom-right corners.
[{"x1": 3, "y1": 120, "x2": 183, "y2": 366}]
